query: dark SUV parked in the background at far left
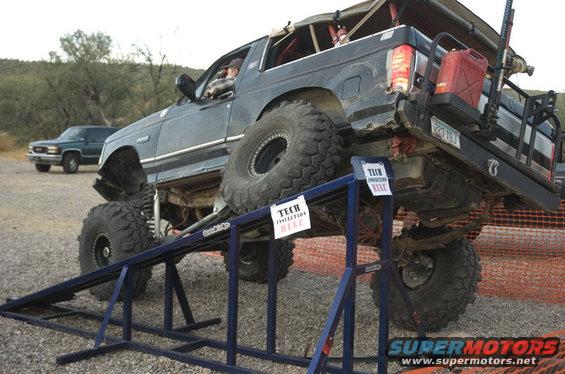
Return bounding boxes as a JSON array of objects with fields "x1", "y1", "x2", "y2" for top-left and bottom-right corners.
[{"x1": 27, "y1": 126, "x2": 118, "y2": 174}]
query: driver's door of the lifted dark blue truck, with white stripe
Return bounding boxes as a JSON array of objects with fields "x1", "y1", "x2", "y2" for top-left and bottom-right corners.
[{"x1": 155, "y1": 46, "x2": 250, "y2": 183}]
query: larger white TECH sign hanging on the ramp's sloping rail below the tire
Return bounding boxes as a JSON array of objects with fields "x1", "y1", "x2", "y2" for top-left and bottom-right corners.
[{"x1": 271, "y1": 196, "x2": 310, "y2": 239}]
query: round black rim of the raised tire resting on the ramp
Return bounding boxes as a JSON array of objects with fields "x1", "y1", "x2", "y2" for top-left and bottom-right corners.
[{"x1": 249, "y1": 132, "x2": 290, "y2": 176}]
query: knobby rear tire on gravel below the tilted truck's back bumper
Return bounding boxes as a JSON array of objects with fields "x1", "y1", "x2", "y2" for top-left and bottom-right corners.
[{"x1": 371, "y1": 239, "x2": 481, "y2": 331}]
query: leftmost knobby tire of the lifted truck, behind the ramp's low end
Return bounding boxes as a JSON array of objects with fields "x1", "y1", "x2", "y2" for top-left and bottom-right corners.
[{"x1": 78, "y1": 201, "x2": 153, "y2": 300}]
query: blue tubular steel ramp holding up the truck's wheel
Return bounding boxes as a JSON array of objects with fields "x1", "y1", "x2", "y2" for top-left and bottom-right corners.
[{"x1": 0, "y1": 157, "x2": 423, "y2": 373}]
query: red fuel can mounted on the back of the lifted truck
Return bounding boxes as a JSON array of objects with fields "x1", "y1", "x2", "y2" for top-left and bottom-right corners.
[{"x1": 435, "y1": 48, "x2": 488, "y2": 108}]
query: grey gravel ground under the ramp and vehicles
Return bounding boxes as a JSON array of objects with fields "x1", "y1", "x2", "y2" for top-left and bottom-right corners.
[{"x1": 0, "y1": 159, "x2": 565, "y2": 373}]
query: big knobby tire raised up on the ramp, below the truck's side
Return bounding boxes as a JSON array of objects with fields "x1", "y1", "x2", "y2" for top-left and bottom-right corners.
[{"x1": 221, "y1": 101, "x2": 341, "y2": 213}]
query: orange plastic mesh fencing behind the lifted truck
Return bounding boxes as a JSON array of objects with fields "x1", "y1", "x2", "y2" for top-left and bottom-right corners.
[{"x1": 294, "y1": 200, "x2": 565, "y2": 304}]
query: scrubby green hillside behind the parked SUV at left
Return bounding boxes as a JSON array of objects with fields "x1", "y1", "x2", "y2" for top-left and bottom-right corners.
[{"x1": 0, "y1": 59, "x2": 203, "y2": 143}]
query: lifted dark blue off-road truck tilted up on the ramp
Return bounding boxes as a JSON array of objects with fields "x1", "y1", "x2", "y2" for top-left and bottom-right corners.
[{"x1": 79, "y1": 0, "x2": 561, "y2": 330}]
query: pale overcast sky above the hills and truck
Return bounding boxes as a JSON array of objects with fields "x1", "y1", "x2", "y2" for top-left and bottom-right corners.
[{"x1": 0, "y1": 0, "x2": 565, "y2": 91}]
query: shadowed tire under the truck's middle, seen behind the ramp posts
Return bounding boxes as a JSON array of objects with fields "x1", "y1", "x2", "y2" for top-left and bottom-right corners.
[{"x1": 222, "y1": 240, "x2": 294, "y2": 283}]
